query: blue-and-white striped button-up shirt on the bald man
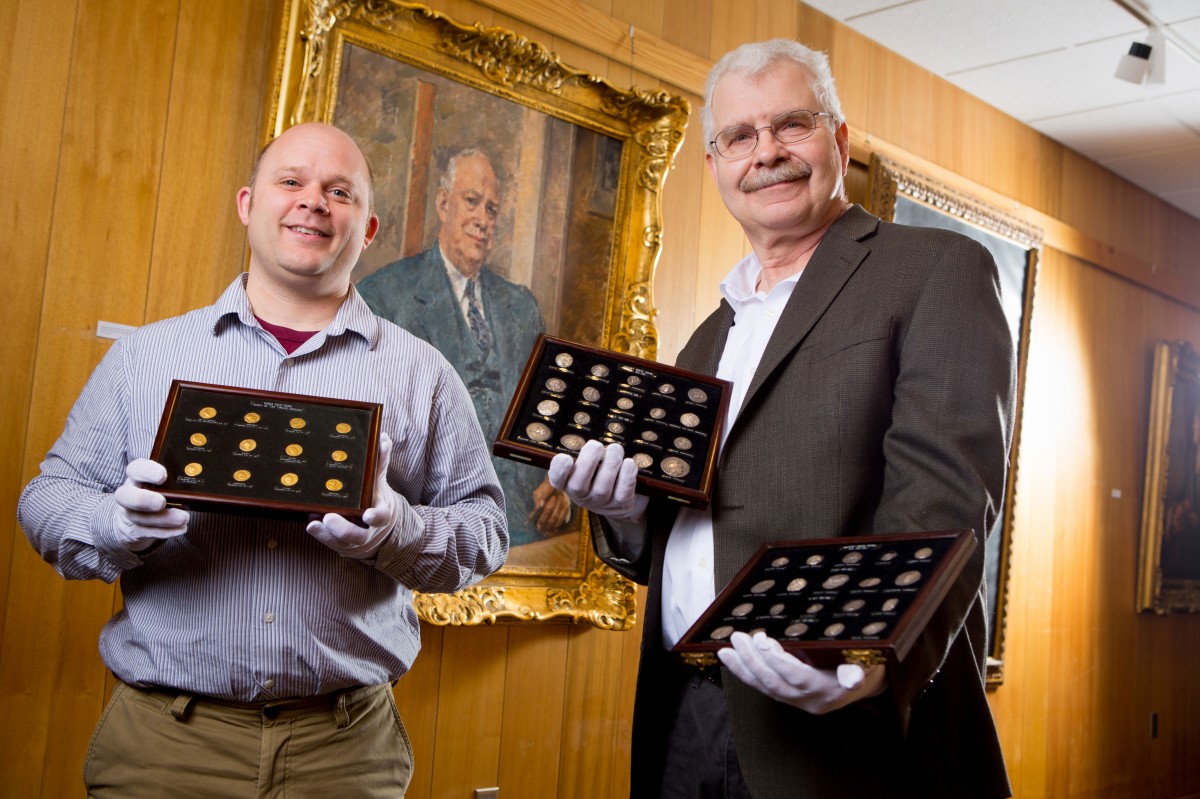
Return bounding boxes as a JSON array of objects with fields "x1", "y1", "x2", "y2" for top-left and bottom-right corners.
[{"x1": 18, "y1": 275, "x2": 508, "y2": 701}]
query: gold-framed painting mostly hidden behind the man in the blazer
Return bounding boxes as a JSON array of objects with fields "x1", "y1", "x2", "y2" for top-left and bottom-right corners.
[{"x1": 868, "y1": 155, "x2": 1042, "y2": 685}]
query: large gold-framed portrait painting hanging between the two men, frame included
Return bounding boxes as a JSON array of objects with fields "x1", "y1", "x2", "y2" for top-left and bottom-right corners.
[{"x1": 265, "y1": 0, "x2": 689, "y2": 630}]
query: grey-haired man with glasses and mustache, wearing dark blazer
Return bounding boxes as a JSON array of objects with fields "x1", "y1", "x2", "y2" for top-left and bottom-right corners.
[{"x1": 550, "y1": 40, "x2": 1015, "y2": 799}]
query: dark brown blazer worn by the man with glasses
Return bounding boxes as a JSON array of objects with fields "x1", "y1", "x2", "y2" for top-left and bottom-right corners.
[{"x1": 595, "y1": 206, "x2": 1015, "y2": 799}]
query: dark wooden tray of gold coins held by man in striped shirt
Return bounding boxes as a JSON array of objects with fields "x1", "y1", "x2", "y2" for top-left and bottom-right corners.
[{"x1": 150, "y1": 380, "x2": 382, "y2": 521}]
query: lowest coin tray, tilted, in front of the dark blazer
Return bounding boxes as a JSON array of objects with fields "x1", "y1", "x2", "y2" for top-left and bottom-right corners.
[{"x1": 673, "y1": 530, "x2": 976, "y2": 667}]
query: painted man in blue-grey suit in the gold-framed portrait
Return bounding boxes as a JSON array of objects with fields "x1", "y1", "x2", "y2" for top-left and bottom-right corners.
[{"x1": 358, "y1": 149, "x2": 570, "y2": 547}]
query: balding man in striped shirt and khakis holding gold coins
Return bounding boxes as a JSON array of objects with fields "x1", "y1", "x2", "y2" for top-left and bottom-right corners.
[{"x1": 18, "y1": 124, "x2": 509, "y2": 797}]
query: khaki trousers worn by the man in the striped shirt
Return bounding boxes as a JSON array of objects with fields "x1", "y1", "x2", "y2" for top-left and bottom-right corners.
[{"x1": 84, "y1": 683, "x2": 413, "y2": 799}]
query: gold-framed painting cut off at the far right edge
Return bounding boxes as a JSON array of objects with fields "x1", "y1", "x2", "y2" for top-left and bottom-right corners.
[{"x1": 1138, "y1": 341, "x2": 1200, "y2": 614}]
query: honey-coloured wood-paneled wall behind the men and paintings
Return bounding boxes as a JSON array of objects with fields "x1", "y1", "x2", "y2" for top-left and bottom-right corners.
[{"x1": 7, "y1": 0, "x2": 1200, "y2": 799}]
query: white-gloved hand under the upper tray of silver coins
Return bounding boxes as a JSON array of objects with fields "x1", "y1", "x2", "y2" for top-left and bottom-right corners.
[{"x1": 548, "y1": 439, "x2": 649, "y2": 522}]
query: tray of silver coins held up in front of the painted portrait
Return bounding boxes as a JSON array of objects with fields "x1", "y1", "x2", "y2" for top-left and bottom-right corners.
[{"x1": 492, "y1": 335, "x2": 730, "y2": 509}]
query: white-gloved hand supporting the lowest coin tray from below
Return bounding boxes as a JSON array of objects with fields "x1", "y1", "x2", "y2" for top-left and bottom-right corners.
[{"x1": 716, "y1": 632, "x2": 887, "y2": 715}]
